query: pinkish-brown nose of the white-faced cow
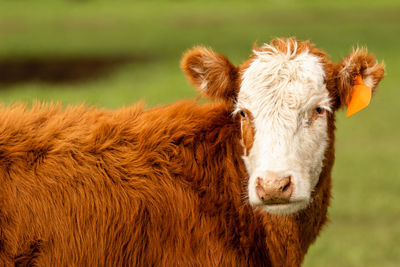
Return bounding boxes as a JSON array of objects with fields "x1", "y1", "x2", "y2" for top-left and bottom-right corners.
[{"x1": 255, "y1": 171, "x2": 293, "y2": 204}]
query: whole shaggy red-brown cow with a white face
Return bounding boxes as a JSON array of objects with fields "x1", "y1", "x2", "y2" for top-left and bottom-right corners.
[{"x1": 0, "y1": 38, "x2": 384, "y2": 266}]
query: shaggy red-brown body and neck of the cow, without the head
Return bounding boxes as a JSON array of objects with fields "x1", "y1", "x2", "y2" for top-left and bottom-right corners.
[{"x1": 0, "y1": 38, "x2": 386, "y2": 266}]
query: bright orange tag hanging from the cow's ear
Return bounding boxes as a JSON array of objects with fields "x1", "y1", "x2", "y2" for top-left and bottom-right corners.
[{"x1": 346, "y1": 75, "x2": 372, "y2": 118}]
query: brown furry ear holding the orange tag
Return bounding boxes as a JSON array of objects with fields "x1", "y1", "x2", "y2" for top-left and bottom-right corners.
[{"x1": 335, "y1": 48, "x2": 385, "y2": 108}]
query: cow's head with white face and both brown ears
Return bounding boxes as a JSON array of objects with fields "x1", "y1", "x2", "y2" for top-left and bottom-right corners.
[{"x1": 182, "y1": 38, "x2": 384, "y2": 214}]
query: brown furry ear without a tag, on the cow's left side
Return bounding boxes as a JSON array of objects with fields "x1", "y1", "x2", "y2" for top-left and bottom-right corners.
[{"x1": 181, "y1": 47, "x2": 238, "y2": 101}]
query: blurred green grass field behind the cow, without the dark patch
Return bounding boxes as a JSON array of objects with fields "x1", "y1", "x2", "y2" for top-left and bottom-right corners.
[{"x1": 0, "y1": 0, "x2": 400, "y2": 267}]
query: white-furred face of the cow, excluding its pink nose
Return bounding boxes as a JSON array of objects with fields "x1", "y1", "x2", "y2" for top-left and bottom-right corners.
[{"x1": 236, "y1": 45, "x2": 331, "y2": 214}]
